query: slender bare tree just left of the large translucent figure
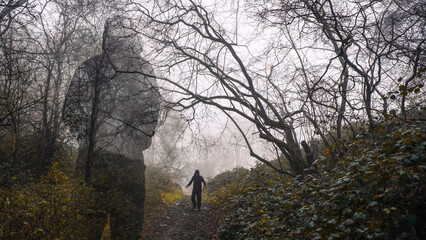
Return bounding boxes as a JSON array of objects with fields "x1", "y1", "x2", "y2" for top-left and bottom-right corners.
[{"x1": 27, "y1": 1, "x2": 103, "y2": 171}]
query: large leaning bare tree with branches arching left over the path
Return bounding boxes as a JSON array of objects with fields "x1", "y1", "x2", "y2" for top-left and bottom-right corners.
[{"x1": 129, "y1": 2, "x2": 307, "y2": 175}]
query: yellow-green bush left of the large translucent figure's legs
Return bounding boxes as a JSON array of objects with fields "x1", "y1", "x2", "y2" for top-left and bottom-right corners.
[{"x1": 0, "y1": 162, "x2": 101, "y2": 239}]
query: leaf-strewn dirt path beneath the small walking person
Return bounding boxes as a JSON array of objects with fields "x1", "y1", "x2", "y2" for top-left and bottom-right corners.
[{"x1": 142, "y1": 196, "x2": 219, "y2": 240}]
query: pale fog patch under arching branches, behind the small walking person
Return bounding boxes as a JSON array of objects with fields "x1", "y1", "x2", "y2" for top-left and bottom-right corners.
[{"x1": 144, "y1": 109, "x2": 275, "y2": 184}]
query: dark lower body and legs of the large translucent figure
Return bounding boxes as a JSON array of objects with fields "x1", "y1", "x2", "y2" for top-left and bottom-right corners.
[{"x1": 90, "y1": 152, "x2": 145, "y2": 239}]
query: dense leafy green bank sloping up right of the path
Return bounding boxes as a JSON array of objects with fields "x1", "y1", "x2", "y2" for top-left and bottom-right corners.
[{"x1": 213, "y1": 123, "x2": 426, "y2": 239}]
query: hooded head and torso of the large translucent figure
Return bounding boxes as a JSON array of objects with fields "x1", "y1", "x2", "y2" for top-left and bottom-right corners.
[{"x1": 63, "y1": 17, "x2": 160, "y2": 159}]
